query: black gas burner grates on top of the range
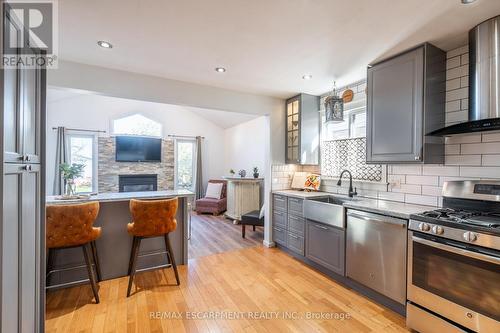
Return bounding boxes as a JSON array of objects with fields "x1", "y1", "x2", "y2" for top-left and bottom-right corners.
[{"x1": 420, "y1": 208, "x2": 500, "y2": 228}]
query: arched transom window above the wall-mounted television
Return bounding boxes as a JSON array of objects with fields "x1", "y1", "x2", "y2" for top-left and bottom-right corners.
[{"x1": 113, "y1": 114, "x2": 162, "y2": 137}]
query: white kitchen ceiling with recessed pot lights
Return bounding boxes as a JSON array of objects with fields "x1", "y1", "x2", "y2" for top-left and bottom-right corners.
[{"x1": 59, "y1": 0, "x2": 500, "y2": 97}]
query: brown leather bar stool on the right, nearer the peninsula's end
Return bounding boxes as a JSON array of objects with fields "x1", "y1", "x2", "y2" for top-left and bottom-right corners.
[{"x1": 127, "y1": 198, "x2": 180, "y2": 297}]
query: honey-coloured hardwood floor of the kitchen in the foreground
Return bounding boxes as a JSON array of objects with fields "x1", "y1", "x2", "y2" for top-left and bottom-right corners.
[{"x1": 46, "y1": 246, "x2": 406, "y2": 333}]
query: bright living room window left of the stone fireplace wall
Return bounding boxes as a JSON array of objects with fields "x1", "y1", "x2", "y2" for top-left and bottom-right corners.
[{"x1": 67, "y1": 133, "x2": 97, "y2": 193}]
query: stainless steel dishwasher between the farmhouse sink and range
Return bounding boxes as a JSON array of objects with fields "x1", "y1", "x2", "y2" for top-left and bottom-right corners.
[{"x1": 346, "y1": 209, "x2": 407, "y2": 304}]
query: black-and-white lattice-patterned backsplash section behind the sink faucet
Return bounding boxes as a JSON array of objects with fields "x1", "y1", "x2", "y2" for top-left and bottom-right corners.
[{"x1": 321, "y1": 138, "x2": 382, "y2": 182}]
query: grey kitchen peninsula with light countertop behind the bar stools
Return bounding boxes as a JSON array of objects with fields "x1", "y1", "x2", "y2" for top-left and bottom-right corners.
[{"x1": 46, "y1": 190, "x2": 194, "y2": 287}]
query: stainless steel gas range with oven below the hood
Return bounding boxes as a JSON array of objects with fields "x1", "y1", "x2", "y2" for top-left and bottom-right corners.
[{"x1": 407, "y1": 181, "x2": 500, "y2": 333}]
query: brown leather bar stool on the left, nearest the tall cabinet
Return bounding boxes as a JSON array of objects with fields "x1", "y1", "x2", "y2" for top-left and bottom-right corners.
[{"x1": 46, "y1": 202, "x2": 102, "y2": 303}]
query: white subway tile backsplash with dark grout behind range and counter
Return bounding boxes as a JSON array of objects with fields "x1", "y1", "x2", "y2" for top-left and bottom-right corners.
[{"x1": 272, "y1": 46, "x2": 500, "y2": 206}]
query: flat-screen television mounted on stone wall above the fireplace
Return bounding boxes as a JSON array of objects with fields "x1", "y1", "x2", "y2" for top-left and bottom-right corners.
[{"x1": 116, "y1": 136, "x2": 161, "y2": 162}]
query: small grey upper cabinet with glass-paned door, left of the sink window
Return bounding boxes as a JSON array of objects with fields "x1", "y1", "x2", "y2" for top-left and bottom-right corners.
[{"x1": 285, "y1": 94, "x2": 320, "y2": 165}]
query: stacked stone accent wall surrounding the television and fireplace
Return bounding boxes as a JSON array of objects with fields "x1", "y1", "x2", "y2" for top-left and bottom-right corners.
[{"x1": 97, "y1": 137, "x2": 175, "y2": 193}]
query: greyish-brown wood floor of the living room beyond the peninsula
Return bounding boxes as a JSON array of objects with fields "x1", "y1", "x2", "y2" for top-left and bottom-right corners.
[{"x1": 188, "y1": 212, "x2": 264, "y2": 259}]
